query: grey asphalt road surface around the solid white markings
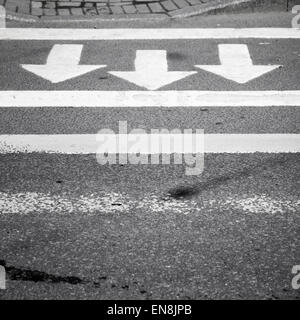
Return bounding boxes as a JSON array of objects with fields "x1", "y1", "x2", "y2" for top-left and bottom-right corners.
[{"x1": 0, "y1": 13, "x2": 300, "y2": 299}]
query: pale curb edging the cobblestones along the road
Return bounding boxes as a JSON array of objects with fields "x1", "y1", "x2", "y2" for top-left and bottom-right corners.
[{"x1": 1, "y1": 0, "x2": 292, "y2": 23}]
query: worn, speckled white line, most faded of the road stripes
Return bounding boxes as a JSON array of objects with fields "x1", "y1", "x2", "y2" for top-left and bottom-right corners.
[{"x1": 0, "y1": 192, "x2": 300, "y2": 215}]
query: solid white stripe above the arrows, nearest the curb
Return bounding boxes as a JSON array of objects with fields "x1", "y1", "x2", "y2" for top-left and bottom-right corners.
[{"x1": 0, "y1": 28, "x2": 300, "y2": 40}]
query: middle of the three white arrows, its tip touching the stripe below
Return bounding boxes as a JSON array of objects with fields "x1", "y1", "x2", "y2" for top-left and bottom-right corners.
[{"x1": 109, "y1": 50, "x2": 197, "y2": 90}]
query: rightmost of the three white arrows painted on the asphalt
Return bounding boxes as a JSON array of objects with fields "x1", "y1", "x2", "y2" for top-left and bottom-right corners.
[{"x1": 195, "y1": 44, "x2": 280, "y2": 83}]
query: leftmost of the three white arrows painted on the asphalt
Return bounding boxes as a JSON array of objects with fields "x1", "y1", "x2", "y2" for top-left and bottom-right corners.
[{"x1": 21, "y1": 44, "x2": 106, "y2": 83}]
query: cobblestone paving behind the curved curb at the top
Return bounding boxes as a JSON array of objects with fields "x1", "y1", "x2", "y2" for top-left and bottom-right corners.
[{"x1": 0, "y1": 0, "x2": 212, "y2": 16}]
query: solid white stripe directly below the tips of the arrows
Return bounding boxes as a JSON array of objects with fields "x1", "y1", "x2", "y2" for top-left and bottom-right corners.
[{"x1": 0, "y1": 90, "x2": 300, "y2": 108}]
